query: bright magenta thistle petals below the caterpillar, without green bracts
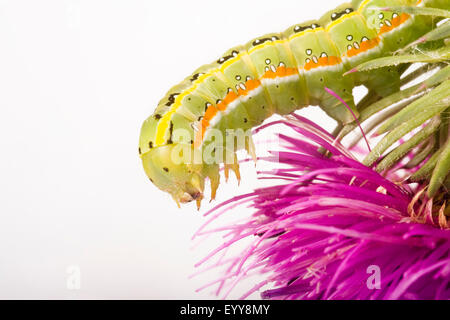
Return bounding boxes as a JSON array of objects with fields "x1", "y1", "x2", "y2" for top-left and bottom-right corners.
[{"x1": 196, "y1": 115, "x2": 450, "y2": 299}]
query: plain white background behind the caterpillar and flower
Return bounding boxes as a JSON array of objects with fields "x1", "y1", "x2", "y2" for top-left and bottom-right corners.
[{"x1": 0, "y1": 0, "x2": 340, "y2": 299}]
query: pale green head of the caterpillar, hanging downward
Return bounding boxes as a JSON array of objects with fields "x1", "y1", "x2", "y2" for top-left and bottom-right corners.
[{"x1": 141, "y1": 144, "x2": 219, "y2": 207}]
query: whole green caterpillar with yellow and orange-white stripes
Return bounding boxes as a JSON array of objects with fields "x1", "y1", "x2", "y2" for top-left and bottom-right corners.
[{"x1": 139, "y1": 0, "x2": 450, "y2": 206}]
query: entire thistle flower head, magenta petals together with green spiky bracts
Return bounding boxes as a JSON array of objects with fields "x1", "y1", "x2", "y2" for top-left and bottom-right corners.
[{"x1": 192, "y1": 7, "x2": 450, "y2": 299}]
